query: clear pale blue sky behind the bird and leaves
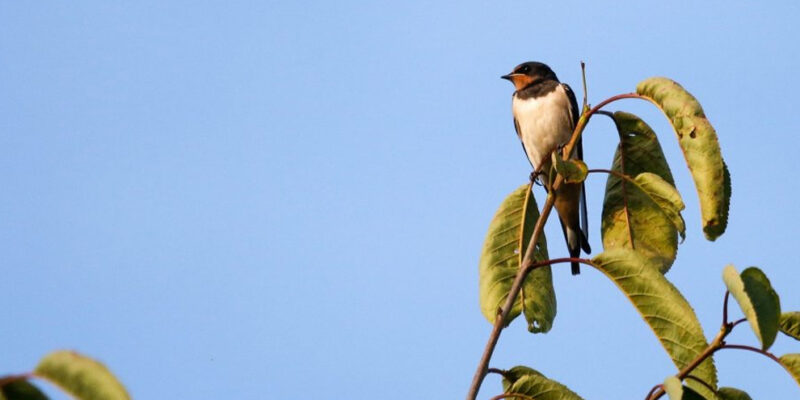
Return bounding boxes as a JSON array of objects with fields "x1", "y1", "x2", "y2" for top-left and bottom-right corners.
[{"x1": 0, "y1": 1, "x2": 800, "y2": 399}]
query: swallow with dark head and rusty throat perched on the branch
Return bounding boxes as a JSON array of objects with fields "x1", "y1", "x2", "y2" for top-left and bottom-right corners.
[{"x1": 501, "y1": 62, "x2": 592, "y2": 275}]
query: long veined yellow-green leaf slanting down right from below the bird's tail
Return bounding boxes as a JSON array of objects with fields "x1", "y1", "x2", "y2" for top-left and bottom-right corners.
[{"x1": 592, "y1": 249, "x2": 717, "y2": 398}]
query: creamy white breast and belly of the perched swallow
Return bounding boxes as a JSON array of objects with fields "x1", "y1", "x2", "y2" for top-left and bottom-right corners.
[{"x1": 511, "y1": 85, "x2": 573, "y2": 172}]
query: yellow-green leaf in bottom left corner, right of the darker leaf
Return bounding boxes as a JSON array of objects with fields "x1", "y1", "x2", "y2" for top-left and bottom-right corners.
[{"x1": 34, "y1": 351, "x2": 130, "y2": 400}]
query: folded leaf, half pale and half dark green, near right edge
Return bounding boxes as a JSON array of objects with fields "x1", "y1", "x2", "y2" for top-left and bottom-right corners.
[{"x1": 722, "y1": 265, "x2": 781, "y2": 350}]
